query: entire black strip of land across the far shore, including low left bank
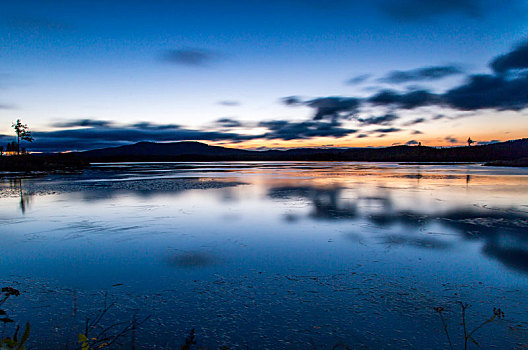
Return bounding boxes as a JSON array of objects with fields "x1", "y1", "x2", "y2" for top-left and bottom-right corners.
[{"x1": 0, "y1": 139, "x2": 528, "y2": 172}]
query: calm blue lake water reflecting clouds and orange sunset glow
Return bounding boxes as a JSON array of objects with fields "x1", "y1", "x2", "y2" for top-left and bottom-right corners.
[{"x1": 0, "y1": 162, "x2": 528, "y2": 349}]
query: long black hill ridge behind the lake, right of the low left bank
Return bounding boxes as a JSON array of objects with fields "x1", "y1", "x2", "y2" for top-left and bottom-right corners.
[{"x1": 77, "y1": 139, "x2": 528, "y2": 162}]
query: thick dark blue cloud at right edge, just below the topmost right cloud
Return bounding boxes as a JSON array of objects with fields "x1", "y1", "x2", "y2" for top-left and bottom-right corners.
[{"x1": 443, "y1": 74, "x2": 528, "y2": 111}]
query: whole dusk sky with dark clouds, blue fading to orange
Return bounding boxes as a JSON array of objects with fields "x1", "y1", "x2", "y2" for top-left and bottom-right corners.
[{"x1": 0, "y1": 0, "x2": 528, "y2": 152}]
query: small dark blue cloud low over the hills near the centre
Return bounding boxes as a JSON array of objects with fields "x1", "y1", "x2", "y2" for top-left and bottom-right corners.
[{"x1": 259, "y1": 120, "x2": 357, "y2": 140}]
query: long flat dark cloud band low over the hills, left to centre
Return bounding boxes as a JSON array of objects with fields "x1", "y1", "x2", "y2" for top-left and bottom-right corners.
[{"x1": 7, "y1": 118, "x2": 364, "y2": 152}]
